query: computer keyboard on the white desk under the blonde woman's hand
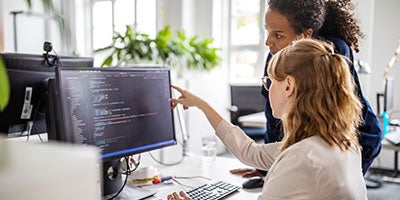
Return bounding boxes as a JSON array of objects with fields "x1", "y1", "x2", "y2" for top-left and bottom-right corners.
[{"x1": 186, "y1": 181, "x2": 240, "y2": 200}]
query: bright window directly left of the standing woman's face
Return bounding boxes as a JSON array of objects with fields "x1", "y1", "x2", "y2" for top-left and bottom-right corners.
[{"x1": 227, "y1": 0, "x2": 267, "y2": 84}]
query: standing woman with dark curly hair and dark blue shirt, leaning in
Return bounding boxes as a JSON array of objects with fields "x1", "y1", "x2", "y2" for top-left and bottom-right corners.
[{"x1": 231, "y1": 0, "x2": 382, "y2": 181}]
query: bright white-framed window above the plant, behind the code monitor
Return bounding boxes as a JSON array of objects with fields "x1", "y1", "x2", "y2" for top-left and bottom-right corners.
[{"x1": 92, "y1": 0, "x2": 156, "y2": 66}]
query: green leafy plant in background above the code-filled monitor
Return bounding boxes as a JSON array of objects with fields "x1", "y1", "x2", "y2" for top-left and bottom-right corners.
[{"x1": 95, "y1": 26, "x2": 221, "y2": 75}]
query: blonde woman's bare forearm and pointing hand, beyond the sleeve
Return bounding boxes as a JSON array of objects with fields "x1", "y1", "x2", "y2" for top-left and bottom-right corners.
[{"x1": 169, "y1": 85, "x2": 222, "y2": 130}]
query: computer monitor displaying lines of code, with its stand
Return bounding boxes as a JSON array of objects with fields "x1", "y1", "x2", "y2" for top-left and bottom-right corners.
[{"x1": 49, "y1": 67, "x2": 177, "y2": 196}]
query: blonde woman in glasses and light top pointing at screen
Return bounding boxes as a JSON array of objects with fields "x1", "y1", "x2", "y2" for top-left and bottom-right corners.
[{"x1": 168, "y1": 39, "x2": 367, "y2": 199}]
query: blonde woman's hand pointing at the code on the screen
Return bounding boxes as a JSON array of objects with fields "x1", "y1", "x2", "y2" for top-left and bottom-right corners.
[{"x1": 169, "y1": 85, "x2": 205, "y2": 110}]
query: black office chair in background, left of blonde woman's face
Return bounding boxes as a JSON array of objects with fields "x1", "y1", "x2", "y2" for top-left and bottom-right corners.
[{"x1": 228, "y1": 85, "x2": 266, "y2": 140}]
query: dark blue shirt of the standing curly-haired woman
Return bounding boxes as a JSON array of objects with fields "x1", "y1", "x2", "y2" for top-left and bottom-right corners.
[{"x1": 261, "y1": 37, "x2": 382, "y2": 174}]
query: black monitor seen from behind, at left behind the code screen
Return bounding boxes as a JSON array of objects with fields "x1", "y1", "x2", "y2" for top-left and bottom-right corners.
[{"x1": 0, "y1": 53, "x2": 93, "y2": 137}]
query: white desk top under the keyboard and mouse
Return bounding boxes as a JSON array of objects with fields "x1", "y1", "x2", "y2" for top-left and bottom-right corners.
[{"x1": 120, "y1": 155, "x2": 261, "y2": 200}]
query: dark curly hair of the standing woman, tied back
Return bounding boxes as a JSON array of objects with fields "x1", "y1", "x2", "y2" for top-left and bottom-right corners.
[{"x1": 268, "y1": 0, "x2": 364, "y2": 52}]
